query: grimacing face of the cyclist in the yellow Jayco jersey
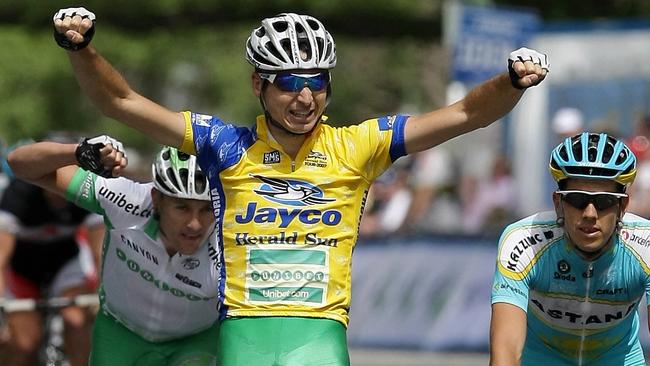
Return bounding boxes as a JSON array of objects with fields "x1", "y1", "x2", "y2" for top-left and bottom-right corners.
[{"x1": 254, "y1": 72, "x2": 327, "y2": 134}]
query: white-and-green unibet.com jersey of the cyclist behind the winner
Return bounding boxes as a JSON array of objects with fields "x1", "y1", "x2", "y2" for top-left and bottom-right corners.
[{"x1": 66, "y1": 169, "x2": 221, "y2": 342}]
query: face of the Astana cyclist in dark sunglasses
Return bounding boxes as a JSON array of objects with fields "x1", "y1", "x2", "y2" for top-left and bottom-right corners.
[{"x1": 553, "y1": 179, "x2": 629, "y2": 257}]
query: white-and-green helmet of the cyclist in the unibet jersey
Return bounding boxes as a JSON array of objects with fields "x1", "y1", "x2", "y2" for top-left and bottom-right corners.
[{"x1": 151, "y1": 146, "x2": 210, "y2": 201}]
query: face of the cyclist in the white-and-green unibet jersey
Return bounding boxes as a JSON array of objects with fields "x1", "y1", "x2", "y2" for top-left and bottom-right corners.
[{"x1": 154, "y1": 192, "x2": 214, "y2": 255}]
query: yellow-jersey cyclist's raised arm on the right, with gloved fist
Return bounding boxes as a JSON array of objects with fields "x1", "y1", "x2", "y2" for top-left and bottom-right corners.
[{"x1": 404, "y1": 48, "x2": 549, "y2": 154}]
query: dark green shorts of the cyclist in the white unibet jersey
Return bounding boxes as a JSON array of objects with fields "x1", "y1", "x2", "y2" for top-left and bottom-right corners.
[{"x1": 90, "y1": 311, "x2": 219, "y2": 366}]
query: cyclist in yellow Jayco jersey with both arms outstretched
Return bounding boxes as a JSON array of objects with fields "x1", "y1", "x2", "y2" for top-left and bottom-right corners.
[{"x1": 54, "y1": 8, "x2": 549, "y2": 366}]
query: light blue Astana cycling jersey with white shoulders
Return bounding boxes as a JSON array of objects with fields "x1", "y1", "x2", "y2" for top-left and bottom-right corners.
[{"x1": 492, "y1": 211, "x2": 650, "y2": 366}]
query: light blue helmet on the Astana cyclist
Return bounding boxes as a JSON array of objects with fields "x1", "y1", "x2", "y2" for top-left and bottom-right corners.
[{"x1": 549, "y1": 132, "x2": 636, "y2": 187}]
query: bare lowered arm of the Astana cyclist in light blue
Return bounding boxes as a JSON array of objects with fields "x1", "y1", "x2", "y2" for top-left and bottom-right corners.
[{"x1": 490, "y1": 302, "x2": 526, "y2": 366}]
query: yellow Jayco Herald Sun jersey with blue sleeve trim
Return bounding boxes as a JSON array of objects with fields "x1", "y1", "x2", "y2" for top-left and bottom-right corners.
[{"x1": 183, "y1": 112, "x2": 408, "y2": 326}]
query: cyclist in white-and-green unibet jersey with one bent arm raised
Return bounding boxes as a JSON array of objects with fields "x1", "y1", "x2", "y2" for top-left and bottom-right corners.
[{"x1": 8, "y1": 136, "x2": 221, "y2": 366}]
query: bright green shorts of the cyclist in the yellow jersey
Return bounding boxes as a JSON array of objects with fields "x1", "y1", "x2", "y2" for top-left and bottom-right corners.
[{"x1": 218, "y1": 317, "x2": 350, "y2": 366}]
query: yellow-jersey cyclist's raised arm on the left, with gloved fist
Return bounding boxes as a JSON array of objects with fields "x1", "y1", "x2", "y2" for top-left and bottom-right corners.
[{"x1": 54, "y1": 8, "x2": 185, "y2": 147}]
